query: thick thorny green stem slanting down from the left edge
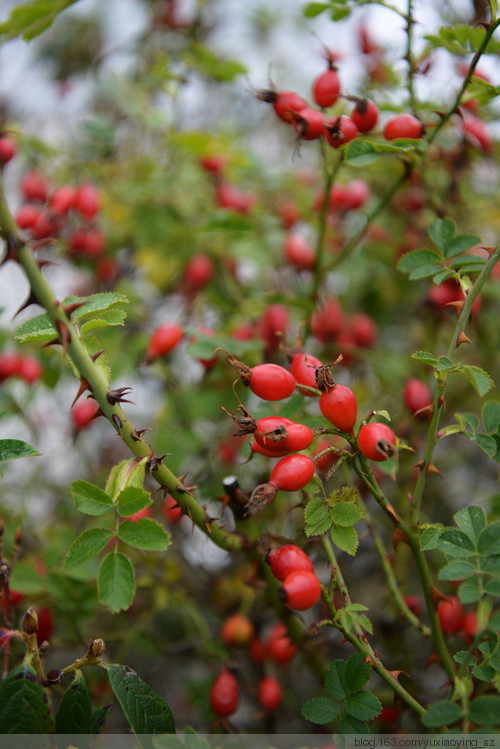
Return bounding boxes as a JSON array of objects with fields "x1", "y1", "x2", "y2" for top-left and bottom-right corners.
[{"x1": 0, "y1": 186, "x2": 244, "y2": 551}]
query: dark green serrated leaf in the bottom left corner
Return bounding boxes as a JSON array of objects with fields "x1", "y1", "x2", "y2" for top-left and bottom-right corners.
[{"x1": 0, "y1": 664, "x2": 52, "y2": 734}]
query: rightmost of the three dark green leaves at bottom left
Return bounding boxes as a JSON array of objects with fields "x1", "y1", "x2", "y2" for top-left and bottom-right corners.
[{"x1": 106, "y1": 663, "x2": 175, "y2": 734}]
